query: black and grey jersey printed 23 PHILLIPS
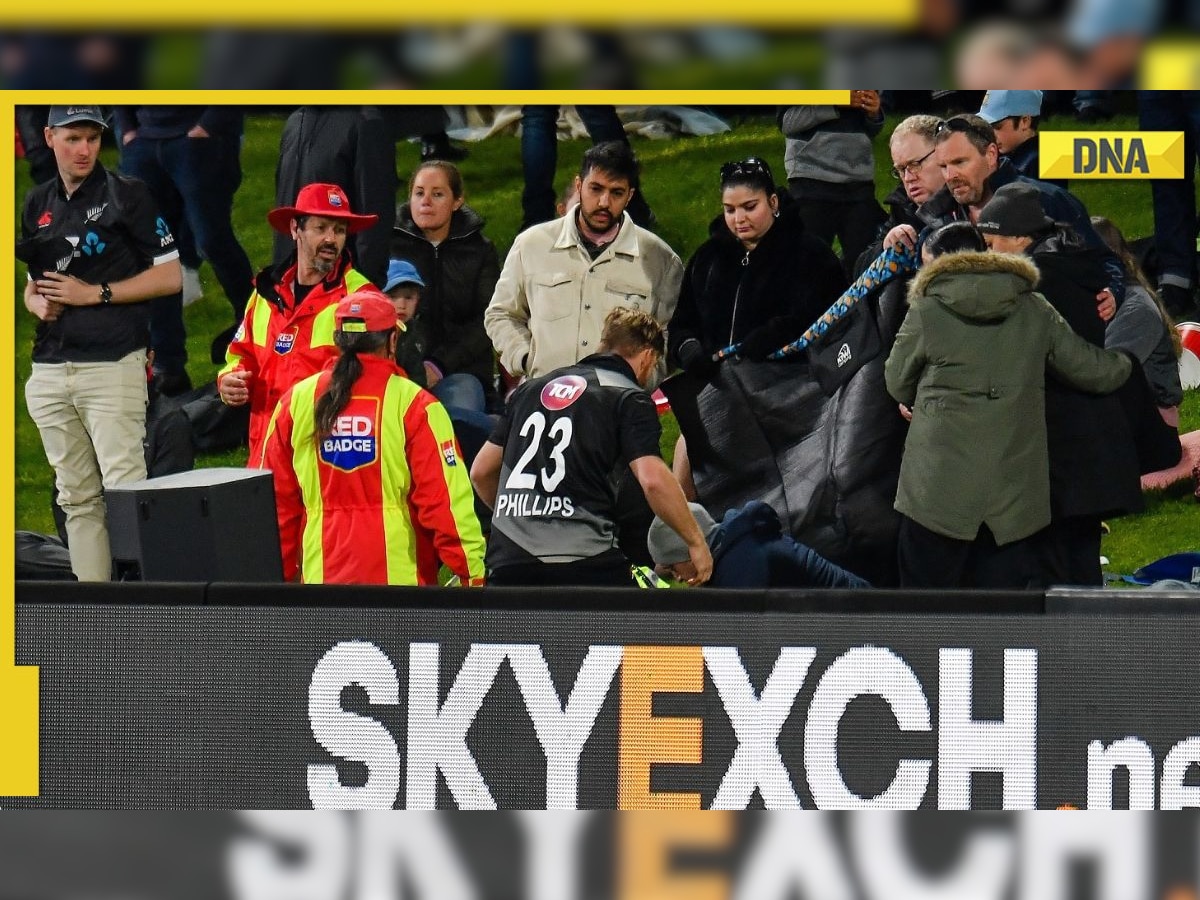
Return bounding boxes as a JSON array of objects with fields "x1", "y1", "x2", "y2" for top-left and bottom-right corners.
[{"x1": 487, "y1": 354, "x2": 661, "y2": 569}]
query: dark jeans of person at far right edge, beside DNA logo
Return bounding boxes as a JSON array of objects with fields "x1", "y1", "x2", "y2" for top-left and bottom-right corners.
[{"x1": 1138, "y1": 91, "x2": 1200, "y2": 288}]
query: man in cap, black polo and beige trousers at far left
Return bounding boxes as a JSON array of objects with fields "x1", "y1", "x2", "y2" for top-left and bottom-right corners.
[{"x1": 17, "y1": 106, "x2": 182, "y2": 581}]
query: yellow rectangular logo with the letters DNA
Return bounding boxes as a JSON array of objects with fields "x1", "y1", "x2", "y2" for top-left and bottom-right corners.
[{"x1": 1038, "y1": 131, "x2": 1183, "y2": 179}]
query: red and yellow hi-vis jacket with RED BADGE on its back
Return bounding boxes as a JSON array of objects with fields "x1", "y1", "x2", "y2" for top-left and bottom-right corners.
[{"x1": 262, "y1": 355, "x2": 484, "y2": 586}]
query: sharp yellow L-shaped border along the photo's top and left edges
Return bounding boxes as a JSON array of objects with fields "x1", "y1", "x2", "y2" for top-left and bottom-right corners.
[{"x1": 0, "y1": 88, "x2": 850, "y2": 797}]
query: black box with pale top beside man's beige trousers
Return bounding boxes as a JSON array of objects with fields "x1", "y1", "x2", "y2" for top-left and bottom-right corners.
[{"x1": 104, "y1": 468, "x2": 283, "y2": 582}]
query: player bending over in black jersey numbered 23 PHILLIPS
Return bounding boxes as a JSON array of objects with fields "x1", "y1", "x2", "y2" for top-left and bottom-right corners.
[{"x1": 470, "y1": 307, "x2": 713, "y2": 586}]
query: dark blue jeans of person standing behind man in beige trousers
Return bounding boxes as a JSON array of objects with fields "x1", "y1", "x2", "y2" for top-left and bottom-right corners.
[{"x1": 121, "y1": 136, "x2": 254, "y2": 372}]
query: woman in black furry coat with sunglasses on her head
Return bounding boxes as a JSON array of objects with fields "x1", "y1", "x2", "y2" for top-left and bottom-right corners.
[{"x1": 667, "y1": 157, "x2": 846, "y2": 374}]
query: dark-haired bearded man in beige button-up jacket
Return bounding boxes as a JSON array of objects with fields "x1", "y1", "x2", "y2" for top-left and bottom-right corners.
[{"x1": 484, "y1": 142, "x2": 683, "y2": 386}]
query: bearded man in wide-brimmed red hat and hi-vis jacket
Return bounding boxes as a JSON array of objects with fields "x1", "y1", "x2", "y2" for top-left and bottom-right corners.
[{"x1": 217, "y1": 184, "x2": 377, "y2": 467}]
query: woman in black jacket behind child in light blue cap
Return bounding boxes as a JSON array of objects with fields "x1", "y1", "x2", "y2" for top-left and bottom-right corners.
[{"x1": 391, "y1": 160, "x2": 500, "y2": 412}]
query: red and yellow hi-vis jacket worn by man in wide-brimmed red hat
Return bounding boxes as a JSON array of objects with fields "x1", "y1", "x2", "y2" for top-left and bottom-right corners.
[{"x1": 217, "y1": 253, "x2": 371, "y2": 468}]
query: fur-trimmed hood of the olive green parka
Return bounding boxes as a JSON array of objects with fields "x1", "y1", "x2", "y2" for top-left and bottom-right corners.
[{"x1": 908, "y1": 252, "x2": 1040, "y2": 320}]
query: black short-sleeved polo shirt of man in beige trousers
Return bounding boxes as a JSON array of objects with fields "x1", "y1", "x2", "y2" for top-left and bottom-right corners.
[{"x1": 17, "y1": 162, "x2": 179, "y2": 362}]
